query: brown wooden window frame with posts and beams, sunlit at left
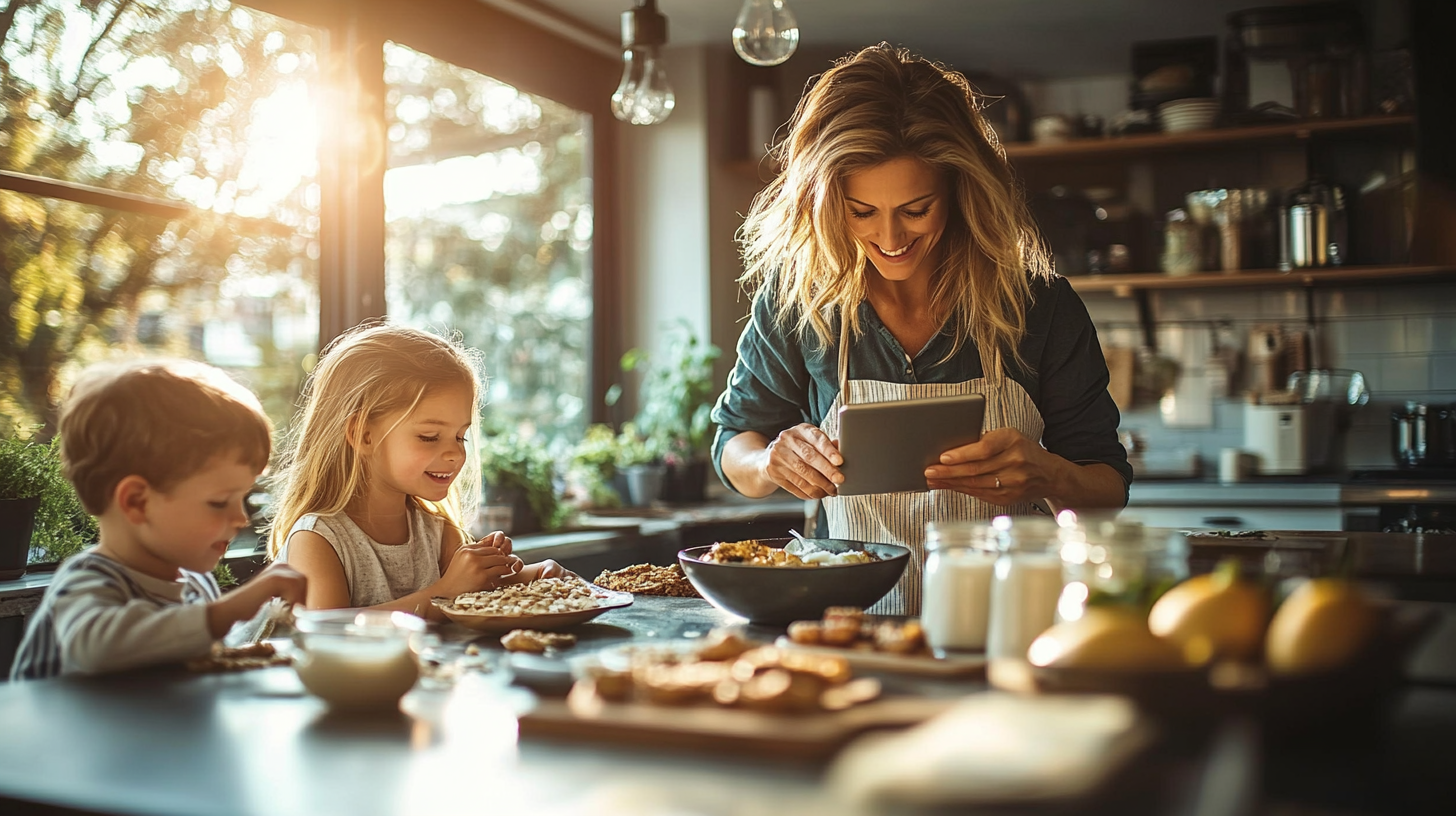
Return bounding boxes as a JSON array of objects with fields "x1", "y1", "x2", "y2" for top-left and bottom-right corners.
[{"x1": 0, "y1": 0, "x2": 623, "y2": 423}]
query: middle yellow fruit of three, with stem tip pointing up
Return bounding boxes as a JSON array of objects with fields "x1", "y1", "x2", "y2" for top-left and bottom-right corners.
[{"x1": 1147, "y1": 570, "x2": 1270, "y2": 663}]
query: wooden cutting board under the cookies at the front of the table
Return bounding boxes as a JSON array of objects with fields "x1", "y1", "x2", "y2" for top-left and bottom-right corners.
[{"x1": 520, "y1": 689, "x2": 958, "y2": 759}]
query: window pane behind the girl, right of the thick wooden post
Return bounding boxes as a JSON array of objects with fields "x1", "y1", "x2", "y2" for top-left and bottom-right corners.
[{"x1": 384, "y1": 42, "x2": 593, "y2": 440}]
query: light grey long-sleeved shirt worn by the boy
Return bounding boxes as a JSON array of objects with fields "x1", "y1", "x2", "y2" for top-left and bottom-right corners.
[{"x1": 10, "y1": 548, "x2": 221, "y2": 680}]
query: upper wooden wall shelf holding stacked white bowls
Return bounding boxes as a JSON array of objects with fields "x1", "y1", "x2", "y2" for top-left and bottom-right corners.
[{"x1": 1005, "y1": 117, "x2": 1415, "y2": 162}]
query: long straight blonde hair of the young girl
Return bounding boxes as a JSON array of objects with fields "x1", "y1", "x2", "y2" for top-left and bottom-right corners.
[{"x1": 268, "y1": 323, "x2": 480, "y2": 558}]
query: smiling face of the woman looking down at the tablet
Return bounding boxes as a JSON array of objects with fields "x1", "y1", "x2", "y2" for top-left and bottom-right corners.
[{"x1": 844, "y1": 156, "x2": 951, "y2": 281}]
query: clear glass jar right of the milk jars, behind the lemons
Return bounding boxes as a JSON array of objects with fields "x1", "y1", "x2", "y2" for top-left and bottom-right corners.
[{"x1": 1057, "y1": 517, "x2": 1188, "y2": 621}]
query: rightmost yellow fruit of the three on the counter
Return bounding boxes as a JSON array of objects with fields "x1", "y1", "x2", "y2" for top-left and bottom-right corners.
[{"x1": 1264, "y1": 578, "x2": 1377, "y2": 675}]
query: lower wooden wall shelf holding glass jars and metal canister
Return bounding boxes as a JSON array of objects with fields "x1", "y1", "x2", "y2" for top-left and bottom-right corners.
[{"x1": 1067, "y1": 265, "x2": 1456, "y2": 297}]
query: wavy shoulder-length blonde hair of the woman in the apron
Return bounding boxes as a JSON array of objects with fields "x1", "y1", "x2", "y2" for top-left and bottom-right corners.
[{"x1": 738, "y1": 44, "x2": 1051, "y2": 379}]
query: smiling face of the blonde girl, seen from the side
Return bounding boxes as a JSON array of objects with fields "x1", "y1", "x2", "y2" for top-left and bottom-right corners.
[{"x1": 364, "y1": 386, "x2": 475, "y2": 501}]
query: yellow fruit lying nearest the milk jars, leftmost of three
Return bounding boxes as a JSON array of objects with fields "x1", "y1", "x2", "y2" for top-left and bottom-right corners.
[{"x1": 1026, "y1": 608, "x2": 1187, "y2": 670}]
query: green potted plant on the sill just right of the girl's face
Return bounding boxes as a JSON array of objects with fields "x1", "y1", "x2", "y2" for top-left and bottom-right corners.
[{"x1": 480, "y1": 431, "x2": 566, "y2": 535}]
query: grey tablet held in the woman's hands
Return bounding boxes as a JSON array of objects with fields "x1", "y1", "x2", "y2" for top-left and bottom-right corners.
[{"x1": 839, "y1": 393, "x2": 986, "y2": 495}]
